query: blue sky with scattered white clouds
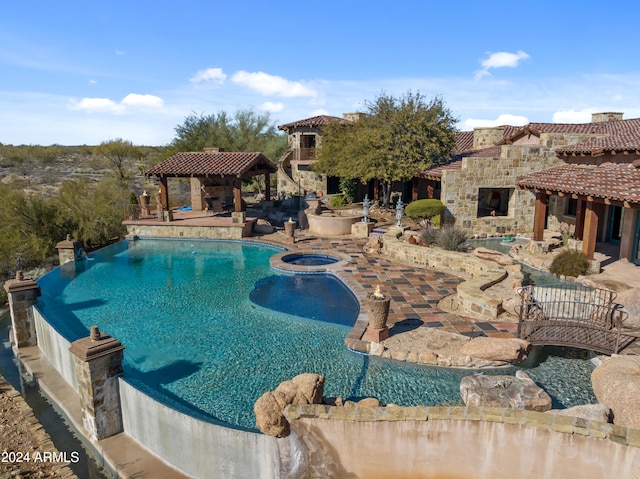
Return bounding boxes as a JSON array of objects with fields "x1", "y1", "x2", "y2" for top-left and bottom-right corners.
[{"x1": 0, "y1": 0, "x2": 640, "y2": 145}]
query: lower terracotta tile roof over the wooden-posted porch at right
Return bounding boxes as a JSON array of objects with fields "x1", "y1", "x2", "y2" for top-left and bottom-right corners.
[{"x1": 516, "y1": 160, "x2": 640, "y2": 204}]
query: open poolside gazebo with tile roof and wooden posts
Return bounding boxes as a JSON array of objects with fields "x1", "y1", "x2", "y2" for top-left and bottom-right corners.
[{"x1": 145, "y1": 148, "x2": 277, "y2": 221}]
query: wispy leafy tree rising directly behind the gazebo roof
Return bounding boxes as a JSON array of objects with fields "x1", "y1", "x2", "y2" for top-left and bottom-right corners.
[{"x1": 168, "y1": 110, "x2": 287, "y2": 162}]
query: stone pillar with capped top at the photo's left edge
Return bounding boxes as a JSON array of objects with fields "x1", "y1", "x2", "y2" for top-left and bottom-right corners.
[{"x1": 4, "y1": 271, "x2": 40, "y2": 348}]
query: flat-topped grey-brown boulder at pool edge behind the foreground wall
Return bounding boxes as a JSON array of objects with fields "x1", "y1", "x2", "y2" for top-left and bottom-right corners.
[{"x1": 460, "y1": 371, "x2": 551, "y2": 412}]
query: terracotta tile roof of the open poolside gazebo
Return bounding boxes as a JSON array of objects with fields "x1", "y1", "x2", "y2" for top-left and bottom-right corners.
[{"x1": 145, "y1": 151, "x2": 277, "y2": 177}]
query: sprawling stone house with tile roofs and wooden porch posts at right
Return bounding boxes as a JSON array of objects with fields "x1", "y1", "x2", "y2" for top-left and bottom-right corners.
[{"x1": 416, "y1": 113, "x2": 640, "y2": 261}]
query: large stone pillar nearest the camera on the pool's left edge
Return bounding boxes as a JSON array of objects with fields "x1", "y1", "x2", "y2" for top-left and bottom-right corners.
[{"x1": 69, "y1": 326, "x2": 124, "y2": 441}]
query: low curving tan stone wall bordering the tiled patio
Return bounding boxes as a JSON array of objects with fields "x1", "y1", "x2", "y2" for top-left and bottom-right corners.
[{"x1": 382, "y1": 233, "x2": 507, "y2": 318}]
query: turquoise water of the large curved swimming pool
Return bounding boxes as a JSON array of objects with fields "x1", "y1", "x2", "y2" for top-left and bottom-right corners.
[{"x1": 33, "y1": 240, "x2": 595, "y2": 429}]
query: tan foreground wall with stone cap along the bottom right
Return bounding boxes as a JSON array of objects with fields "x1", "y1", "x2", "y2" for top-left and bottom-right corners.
[{"x1": 285, "y1": 405, "x2": 640, "y2": 479}]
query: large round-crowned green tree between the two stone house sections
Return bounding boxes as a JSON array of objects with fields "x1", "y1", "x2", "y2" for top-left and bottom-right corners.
[{"x1": 314, "y1": 92, "x2": 457, "y2": 208}]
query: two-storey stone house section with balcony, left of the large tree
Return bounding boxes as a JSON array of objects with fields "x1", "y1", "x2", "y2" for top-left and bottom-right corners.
[{"x1": 278, "y1": 113, "x2": 356, "y2": 195}]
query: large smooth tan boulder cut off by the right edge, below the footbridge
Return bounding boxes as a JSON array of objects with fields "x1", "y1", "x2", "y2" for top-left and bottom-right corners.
[{"x1": 591, "y1": 355, "x2": 640, "y2": 429}]
